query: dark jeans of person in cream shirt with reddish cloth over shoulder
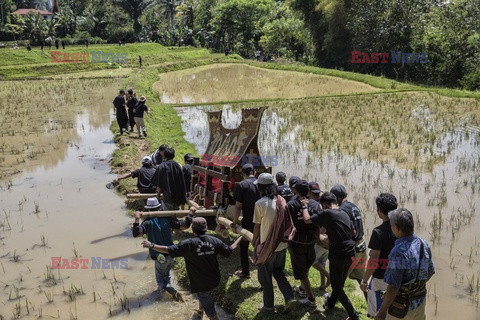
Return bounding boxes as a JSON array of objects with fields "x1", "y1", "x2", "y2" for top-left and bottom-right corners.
[{"x1": 258, "y1": 249, "x2": 293, "y2": 308}]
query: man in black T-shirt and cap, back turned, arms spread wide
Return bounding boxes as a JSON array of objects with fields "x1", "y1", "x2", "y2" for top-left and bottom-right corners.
[{"x1": 142, "y1": 215, "x2": 242, "y2": 320}]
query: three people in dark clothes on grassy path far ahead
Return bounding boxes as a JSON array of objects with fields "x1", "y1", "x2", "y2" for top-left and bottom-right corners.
[{"x1": 113, "y1": 89, "x2": 150, "y2": 138}]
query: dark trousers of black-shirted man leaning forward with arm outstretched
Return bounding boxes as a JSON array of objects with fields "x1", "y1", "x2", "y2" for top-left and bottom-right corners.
[{"x1": 327, "y1": 257, "x2": 358, "y2": 320}]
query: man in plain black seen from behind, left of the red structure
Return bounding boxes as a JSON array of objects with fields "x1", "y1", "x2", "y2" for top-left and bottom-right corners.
[{"x1": 152, "y1": 148, "x2": 187, "y2": 210}]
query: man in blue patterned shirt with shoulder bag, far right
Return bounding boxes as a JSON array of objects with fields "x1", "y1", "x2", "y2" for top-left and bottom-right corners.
[{"x1": 375, "y1": 208, "x2": 435, "y2": 320}]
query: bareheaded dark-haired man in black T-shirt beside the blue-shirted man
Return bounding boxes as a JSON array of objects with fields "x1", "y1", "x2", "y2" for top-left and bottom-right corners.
[{"x1": 358, "y1": 193, "x2": 398, "y2": 317}]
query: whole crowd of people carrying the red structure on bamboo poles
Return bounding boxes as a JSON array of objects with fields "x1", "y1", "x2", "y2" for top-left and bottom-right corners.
[{"x1": 113, "y1": 145, "x2": 435, "y2": 320}]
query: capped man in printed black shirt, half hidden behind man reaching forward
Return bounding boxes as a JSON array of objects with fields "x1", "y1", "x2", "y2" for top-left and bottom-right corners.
[{"x1": 330, "y1": 184, "x2": 368, "y2": 302}]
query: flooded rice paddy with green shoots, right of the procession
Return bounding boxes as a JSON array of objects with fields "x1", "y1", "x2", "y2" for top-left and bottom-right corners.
[{"x1": 177, "y1": 79, "x2": 480, "y2": 320}]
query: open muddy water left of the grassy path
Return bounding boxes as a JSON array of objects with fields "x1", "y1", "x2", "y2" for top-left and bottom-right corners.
[{"x1": 0, "y1": 80, "x2": 221, "y2": 319}]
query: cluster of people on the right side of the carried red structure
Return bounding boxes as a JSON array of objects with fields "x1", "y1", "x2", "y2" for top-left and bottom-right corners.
[{"x1": 233, "y1": 164, "x2": 434, "y2": 320}]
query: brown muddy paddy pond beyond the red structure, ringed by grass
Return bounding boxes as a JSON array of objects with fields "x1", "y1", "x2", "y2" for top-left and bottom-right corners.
[{"x1": 153, "y1": 64, "x2": 378, "y2": 103}]
